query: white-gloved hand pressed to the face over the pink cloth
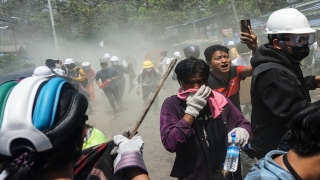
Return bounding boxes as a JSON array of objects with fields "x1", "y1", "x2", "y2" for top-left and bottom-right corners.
[{"x1": 184, "y1": 85, "x2": 211, "y2": 117}]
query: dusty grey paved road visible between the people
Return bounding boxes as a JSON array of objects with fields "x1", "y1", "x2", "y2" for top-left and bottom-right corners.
[{"x1": 88, "y1": 87, "x2": 175, "y2": 180}]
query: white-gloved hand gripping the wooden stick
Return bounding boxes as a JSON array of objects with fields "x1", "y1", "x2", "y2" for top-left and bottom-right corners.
[{"x1": 113, "y1": 133, "x2": 146, "y2": 172}]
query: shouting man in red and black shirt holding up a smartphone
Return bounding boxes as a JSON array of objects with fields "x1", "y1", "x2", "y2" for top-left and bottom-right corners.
[{"x1": 204, "y1": 26, "x2": 258, "y2": 178}]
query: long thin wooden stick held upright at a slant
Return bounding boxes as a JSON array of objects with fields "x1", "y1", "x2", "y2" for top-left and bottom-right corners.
[{"x1": 129, "y1": 59, "x2": 177, "y2": 139}]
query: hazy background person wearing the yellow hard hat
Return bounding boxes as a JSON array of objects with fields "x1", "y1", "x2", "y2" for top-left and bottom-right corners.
[{"x1": 136, "y1": 60, "x2": 161, "y2": 114}]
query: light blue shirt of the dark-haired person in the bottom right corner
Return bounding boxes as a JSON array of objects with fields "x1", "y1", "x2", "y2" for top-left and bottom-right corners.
[{"x1": 245, "y1": 150, "x2": 294, "y2": 180}]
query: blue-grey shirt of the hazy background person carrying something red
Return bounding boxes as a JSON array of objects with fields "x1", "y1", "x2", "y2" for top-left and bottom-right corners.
[{"x1": 96, "y1": 68, "x2": 119, "y2": 89}]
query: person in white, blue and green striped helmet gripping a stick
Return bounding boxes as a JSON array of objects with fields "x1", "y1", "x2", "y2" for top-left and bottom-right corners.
[{"x1": 0, "y1": 77, "x2": 149, "y2": 180}]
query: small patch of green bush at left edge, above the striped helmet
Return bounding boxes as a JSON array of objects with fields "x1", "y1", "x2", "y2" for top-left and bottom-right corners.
[{"x1": 0, "y1": 54, "x2": 25, "y2": 75}]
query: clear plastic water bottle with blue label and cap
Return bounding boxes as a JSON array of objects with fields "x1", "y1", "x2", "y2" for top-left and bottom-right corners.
[{"x1": 223, "y1": 133, "x2": 240, "y2": 172}]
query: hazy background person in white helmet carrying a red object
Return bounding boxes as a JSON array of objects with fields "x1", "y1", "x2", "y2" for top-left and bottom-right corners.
[{"x1": 96, "y1": 60, "x2": 122, "y2": 116}]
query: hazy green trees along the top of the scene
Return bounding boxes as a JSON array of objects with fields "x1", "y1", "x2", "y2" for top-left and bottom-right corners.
[{"x1": 0, "y1": 0, "x2": 316, "y2": 43}]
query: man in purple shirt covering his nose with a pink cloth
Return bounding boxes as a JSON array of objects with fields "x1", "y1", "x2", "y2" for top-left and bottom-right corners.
[{"x1": 160, "y1": 57, "x2": 251, "y2": 180}]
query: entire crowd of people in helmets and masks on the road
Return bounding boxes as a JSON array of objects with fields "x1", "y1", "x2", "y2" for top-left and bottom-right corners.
[{"x1": 0, "y1": 8, "x2": 320, "y2": 180}]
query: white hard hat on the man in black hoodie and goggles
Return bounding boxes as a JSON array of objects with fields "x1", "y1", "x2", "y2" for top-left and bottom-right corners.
[{"x1": 266, "y1": 8, "x2": 316, "y2": 34}]
